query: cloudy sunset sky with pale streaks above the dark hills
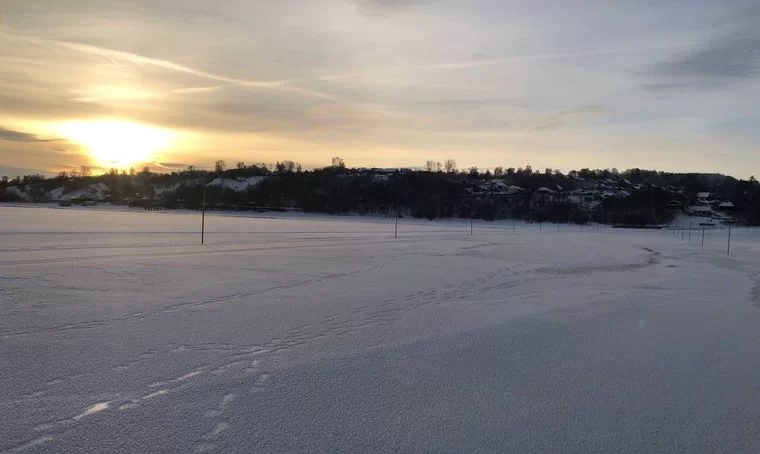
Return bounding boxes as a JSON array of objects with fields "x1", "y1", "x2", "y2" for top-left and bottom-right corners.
[{"x1": 0, "y1": 0, "x2": 760, "y2": 178}]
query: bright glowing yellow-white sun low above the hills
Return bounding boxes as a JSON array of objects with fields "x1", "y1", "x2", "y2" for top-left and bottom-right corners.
[{"x1": 57, "y1": 120, "x2": 173, "y2": 168}]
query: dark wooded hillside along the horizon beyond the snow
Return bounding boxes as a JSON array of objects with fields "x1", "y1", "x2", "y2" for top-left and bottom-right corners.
[{"x1": 0, "y1": 158, "x2": 760, "y2": 225}]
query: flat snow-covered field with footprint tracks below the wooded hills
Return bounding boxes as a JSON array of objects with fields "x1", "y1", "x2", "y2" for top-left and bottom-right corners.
[{"x1": 0, "y1": 207, "x2": 760, "y2": 453}]
